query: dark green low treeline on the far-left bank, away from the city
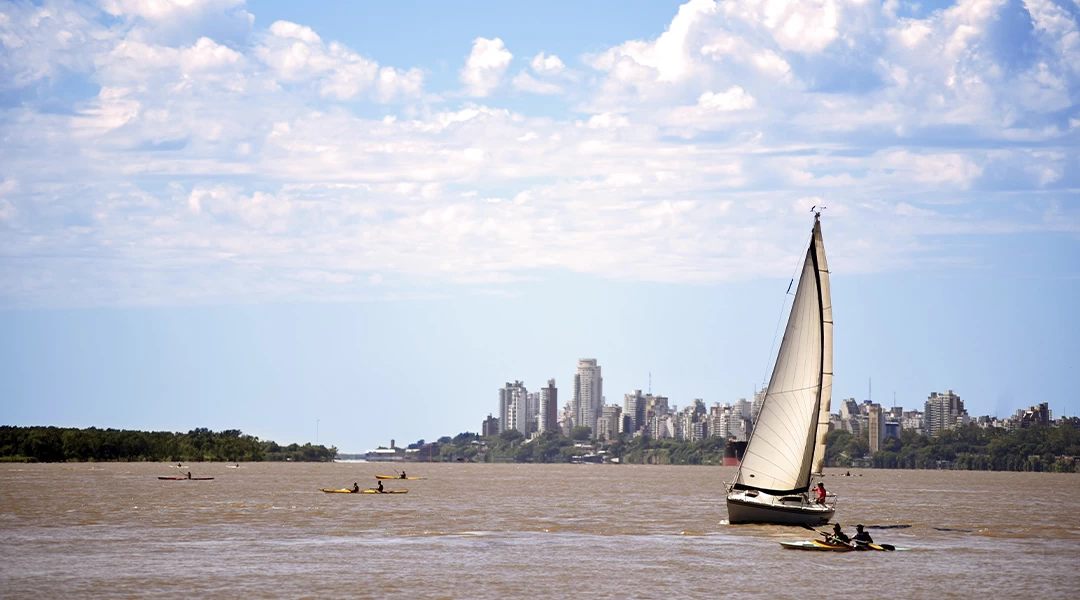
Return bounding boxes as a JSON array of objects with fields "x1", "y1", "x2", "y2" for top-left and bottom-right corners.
[{"x1": 0, "y1": 425, "x2": 337, "y2": 462}]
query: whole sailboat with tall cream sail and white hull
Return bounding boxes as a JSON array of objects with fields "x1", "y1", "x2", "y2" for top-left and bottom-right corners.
[{"x1": 728, "y1": 212, "x2": 836, "y2": 526}]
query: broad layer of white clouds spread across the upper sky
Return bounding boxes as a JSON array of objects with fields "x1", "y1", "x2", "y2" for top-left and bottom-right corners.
[{"x1": 0, "y1": 0, "x2": 1080, "y2": 305}]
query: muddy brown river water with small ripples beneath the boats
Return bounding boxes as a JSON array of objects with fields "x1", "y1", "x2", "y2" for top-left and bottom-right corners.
[{"x1": 0, "y1": 463, "x2": 1080, "y2": 599}]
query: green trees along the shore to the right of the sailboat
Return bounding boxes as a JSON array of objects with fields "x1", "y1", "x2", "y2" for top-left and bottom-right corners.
[{"x1": 825, "y1": 425, "x2": 1080, "y2": 473}]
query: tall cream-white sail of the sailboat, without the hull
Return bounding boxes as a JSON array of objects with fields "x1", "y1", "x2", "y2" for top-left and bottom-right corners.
[{"x1": 734, "y1": 219, "x2": 833, "y2": 493}]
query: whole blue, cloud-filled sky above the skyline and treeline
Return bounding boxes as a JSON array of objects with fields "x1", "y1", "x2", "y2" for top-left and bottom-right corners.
[{"x1": 0, "y1": 0, "x2": 1080, "y2": 451}]
